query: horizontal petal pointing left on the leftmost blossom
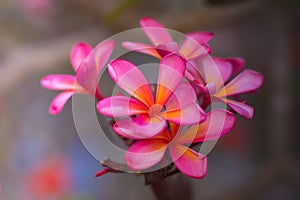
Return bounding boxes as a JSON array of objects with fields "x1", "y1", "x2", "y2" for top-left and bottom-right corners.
[{"x1": 41, "y1": 74, "x2": 76, "y2": 90}]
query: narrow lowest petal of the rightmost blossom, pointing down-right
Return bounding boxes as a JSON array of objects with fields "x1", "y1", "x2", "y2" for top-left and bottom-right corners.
[{"x1": 222, "y1": 98, "x2": 254, "y2": 119}]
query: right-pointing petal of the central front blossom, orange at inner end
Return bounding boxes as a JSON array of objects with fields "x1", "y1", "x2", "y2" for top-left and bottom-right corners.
[{"x1": 160, "y1": 103, "x2": 206, "y2": 125}]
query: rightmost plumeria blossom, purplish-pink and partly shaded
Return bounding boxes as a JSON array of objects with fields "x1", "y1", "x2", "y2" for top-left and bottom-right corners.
[{"x1": 188, "y1": 57, "x2": 263, "y2": 119}]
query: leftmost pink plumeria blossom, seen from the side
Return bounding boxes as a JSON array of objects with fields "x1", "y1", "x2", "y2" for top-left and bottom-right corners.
[{"x1": 41, "y1": 40, "x2": 114, "y2": 115}]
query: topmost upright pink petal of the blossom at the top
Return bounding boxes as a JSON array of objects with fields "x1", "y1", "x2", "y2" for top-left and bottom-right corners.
[{"x1": 140, "y1": 17, "x2": 173, "y2": 46}]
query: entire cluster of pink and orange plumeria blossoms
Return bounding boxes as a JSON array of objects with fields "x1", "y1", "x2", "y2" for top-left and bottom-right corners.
[{"x1": 41, "y1": 17, "x2": 263, "y2": 178}]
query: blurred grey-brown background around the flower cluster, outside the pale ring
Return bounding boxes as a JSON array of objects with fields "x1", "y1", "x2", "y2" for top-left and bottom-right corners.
[{"x1": 0, "y1": 0, "x2": 300, "y2": 200}]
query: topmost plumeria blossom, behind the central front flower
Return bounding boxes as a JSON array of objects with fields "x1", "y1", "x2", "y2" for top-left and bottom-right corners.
[{"x1": 122, "y1": 17, "x2": 213, "y2": 60}]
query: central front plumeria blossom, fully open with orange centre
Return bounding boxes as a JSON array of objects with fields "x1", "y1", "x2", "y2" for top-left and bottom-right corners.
[{"x1": 97, "y1": 53, "x2": 205, "y2": 139}]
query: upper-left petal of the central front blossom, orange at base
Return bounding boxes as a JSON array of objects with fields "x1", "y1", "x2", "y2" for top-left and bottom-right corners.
[{"x1": 108, "y1": 59, "x2": 154, "y2": 107}]
